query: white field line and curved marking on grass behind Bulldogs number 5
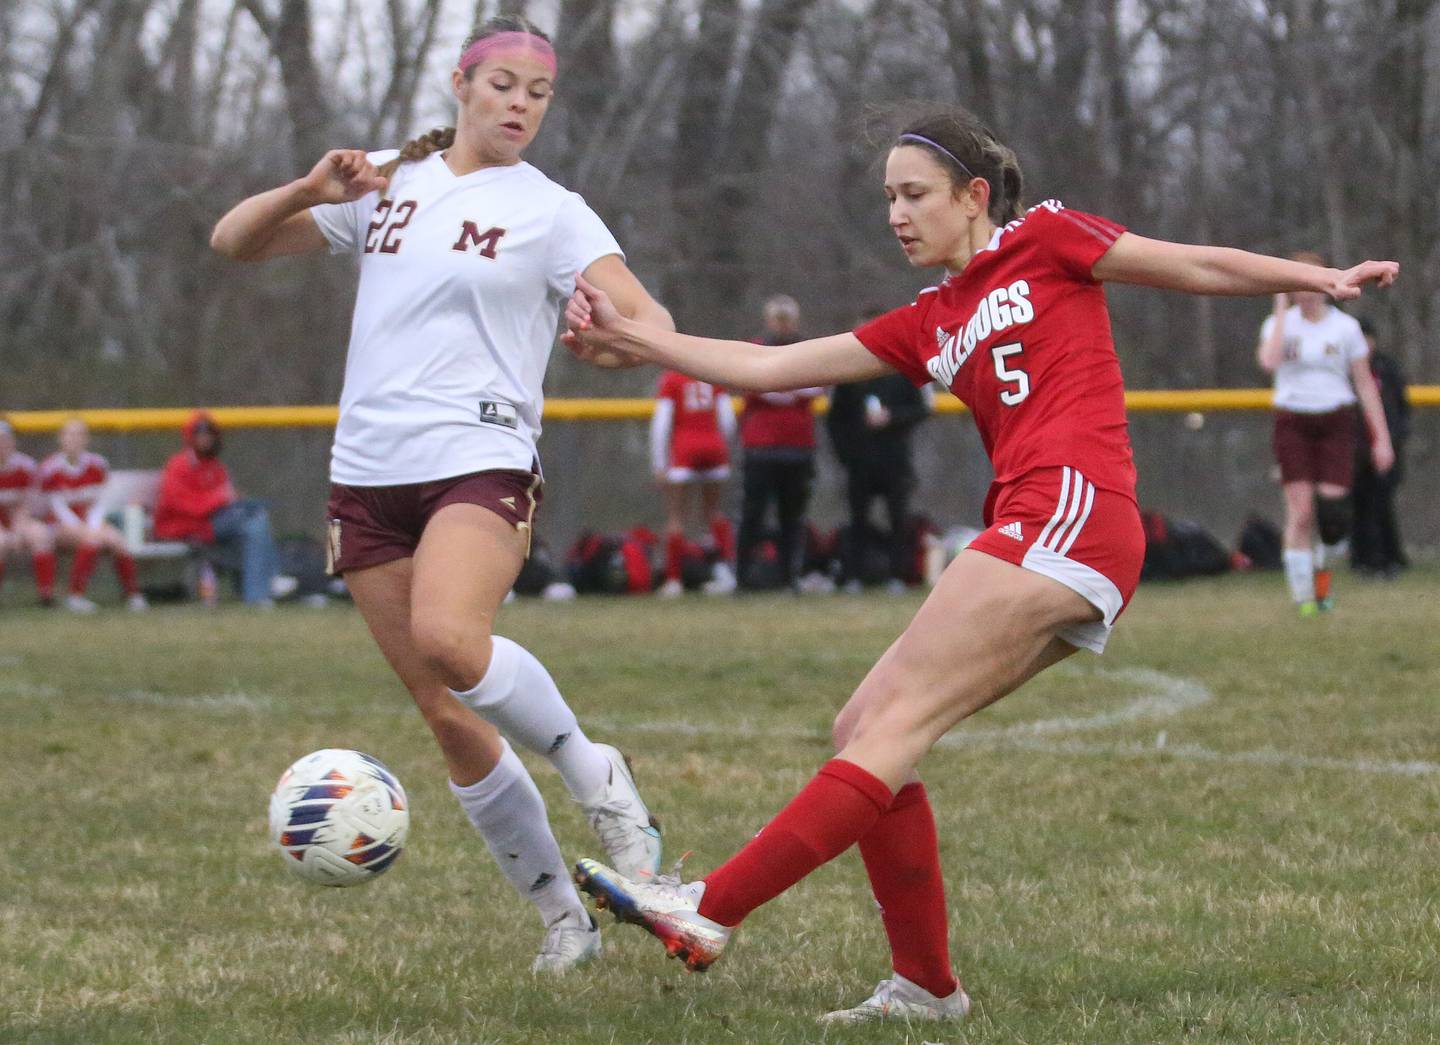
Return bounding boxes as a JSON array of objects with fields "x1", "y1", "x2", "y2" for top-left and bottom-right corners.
[{"x1": 593, "y1": 668, "x2": 1440, "y2": 776}]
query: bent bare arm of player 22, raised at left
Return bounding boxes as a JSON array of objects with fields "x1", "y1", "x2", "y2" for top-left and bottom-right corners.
[{"x1": 210, "y1": 148, "x2": 386, "y2": 261}]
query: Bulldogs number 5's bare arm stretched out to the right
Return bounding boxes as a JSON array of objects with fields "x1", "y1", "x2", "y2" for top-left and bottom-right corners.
[{"x1": 1092, "y1": 232, "x2": 1400, "y2": 301}]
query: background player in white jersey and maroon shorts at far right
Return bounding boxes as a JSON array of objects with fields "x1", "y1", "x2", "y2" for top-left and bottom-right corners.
[{"x1": 1257, "y1": 250, "x2": 1395, "y2": 618}]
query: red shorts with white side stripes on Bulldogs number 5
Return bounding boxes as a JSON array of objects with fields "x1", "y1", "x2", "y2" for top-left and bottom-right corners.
[{"x1": 969, "y1": 468, "x2": 1145, "y2": 653}]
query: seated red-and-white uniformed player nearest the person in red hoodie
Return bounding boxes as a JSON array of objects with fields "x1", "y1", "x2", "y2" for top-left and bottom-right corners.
[{"x1": 35, "y1": 417, "x2": 145, "y2": 613}]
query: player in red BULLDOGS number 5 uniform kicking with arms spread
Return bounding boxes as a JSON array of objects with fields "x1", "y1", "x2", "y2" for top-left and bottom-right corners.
[{"x1": 566, "y1": 109, "x2": 1398, "y2": 1022}]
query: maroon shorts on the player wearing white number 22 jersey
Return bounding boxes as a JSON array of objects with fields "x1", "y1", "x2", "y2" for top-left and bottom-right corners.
[{"x1": 325, "y1": 468, "x2": 541, "y2": 574}]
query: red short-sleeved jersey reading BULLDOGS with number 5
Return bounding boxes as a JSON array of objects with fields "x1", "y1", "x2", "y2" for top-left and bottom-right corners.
[{"x1": 855, "y1": 200, "x2": 1135, "y2": 499}]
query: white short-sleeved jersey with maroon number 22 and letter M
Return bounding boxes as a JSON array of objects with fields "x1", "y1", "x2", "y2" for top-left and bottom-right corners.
[{"x1": 310, "y1": 151, "x2": 621, "y2": 487}]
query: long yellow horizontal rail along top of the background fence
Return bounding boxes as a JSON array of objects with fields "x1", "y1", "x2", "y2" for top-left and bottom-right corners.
[{"x1": 4, "y1": 384, "x2": 1440, "y2": 433}]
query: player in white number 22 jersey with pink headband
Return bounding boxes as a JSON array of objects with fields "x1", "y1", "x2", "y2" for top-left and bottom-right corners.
[{"x1": 212, "y1": 17, "x2": 674, "y2": 972}]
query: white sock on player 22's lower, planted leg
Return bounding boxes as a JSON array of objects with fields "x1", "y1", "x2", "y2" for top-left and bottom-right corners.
[{"x1": 451, "y1": 744, "x2": 585, "y2": 926}]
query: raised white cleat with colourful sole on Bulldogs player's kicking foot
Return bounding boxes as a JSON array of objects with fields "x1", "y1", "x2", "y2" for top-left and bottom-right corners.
[{"x1": 575, "y1": 859, "x2": 734, "y2": 973}]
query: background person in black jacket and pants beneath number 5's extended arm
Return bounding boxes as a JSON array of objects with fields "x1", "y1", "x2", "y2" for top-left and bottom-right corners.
[{"x1": 825, "y1": 314, "x2": 933, "y2": 592}]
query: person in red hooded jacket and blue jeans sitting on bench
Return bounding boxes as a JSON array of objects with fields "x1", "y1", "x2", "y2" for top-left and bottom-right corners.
[{"x1": 154, "y1": 410, "x2": 295, "y2": 606}]
